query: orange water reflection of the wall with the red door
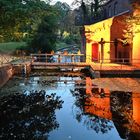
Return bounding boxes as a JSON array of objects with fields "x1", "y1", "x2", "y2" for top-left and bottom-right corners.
[{"x1": 84, "y1": 77, "x2": 112, "y2": 120}]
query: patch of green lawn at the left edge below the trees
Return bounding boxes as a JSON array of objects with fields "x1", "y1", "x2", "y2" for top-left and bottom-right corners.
[{"x1": 0, "y1": 42, "x2": 26, "y2": 54}]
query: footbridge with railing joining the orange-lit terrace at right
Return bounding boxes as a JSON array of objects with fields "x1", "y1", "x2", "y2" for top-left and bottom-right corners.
[{"x1": 31, "y1": 54, "x2": 140, "y2": 76}]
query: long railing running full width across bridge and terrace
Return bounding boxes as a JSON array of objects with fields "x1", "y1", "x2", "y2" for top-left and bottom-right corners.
[{"x1": 0, "y1": 54, "x2": 140, "y2": 70}]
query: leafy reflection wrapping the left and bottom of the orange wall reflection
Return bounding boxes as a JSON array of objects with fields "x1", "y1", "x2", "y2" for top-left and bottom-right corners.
[{"x1": 71, "y1": 89, "x2": 113, "y2": 134}]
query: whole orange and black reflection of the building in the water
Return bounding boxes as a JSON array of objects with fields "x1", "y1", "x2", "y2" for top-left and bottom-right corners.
[{"x1": 83, "y1": 77, "x2": 140, "y2": 140}]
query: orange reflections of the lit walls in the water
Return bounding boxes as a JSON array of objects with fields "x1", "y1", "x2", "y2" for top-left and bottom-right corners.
[{"x1": 84, "y1": 77, "x2": 140, "y2": 134}]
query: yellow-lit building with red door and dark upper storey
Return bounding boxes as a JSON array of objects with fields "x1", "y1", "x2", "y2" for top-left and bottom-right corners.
[{"x1": 85, "y1": 0, "x2": 140, "y2": 64}]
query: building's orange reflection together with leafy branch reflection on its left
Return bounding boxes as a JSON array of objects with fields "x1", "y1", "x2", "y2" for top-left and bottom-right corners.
[{"x1": 72, "y1": 77, "x2": 140, "y2": 140}]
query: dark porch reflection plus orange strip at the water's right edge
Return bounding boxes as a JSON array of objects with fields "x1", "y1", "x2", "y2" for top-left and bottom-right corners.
[{"x1": 111, "y1": 92, "x2": 140, "y2": 140}]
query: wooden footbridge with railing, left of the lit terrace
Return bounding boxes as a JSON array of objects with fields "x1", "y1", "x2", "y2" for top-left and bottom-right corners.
[{"x1": 31, "y1": 54, "x2": 88, "y2": 69}]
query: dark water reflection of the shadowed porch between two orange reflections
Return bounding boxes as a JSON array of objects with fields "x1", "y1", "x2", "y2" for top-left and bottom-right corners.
[{"x1": 110, "y1": 91, "x2": 140, "y2": 140}]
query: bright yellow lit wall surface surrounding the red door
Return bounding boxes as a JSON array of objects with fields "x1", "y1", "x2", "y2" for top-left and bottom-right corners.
[{"x1": 85, "y1": 18, "x2": 113, "y2": 62}]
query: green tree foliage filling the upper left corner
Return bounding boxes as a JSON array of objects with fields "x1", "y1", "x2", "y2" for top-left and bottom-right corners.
[{"x1": 0, "y1": 0, "x2": 50, "y2": 41}]
